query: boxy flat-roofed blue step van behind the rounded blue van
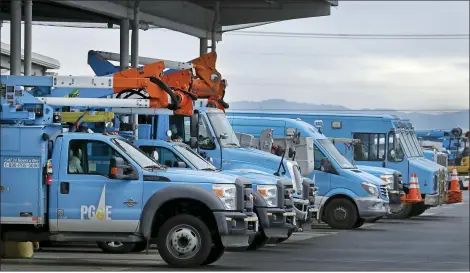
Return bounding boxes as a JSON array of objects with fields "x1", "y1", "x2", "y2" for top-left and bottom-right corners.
[{"x1": 228, "y1": 112, "x2": 447, "y2": 218}]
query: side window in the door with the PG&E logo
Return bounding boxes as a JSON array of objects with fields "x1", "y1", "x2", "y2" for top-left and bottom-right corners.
[{"x1": 68, "y1": 139, "x2": 119, "y2": 177}]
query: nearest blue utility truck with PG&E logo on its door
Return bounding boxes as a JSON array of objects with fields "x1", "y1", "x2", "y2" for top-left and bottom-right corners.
[{"x1": 0, "y1": 76, "x2": 258, "y2": 267}]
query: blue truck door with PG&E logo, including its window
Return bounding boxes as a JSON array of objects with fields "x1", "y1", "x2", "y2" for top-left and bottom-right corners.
[{"x1": 57, "y1": 139, "x2": 143, "y2": 233}]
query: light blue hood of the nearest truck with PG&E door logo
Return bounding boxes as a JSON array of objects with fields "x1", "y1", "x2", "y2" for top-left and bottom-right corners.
[{"x1": 145, "y1": 168, "x2": 237, "y2": 184}]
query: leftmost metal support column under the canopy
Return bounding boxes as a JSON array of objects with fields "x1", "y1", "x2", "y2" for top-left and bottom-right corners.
[{"x1": 10, "y1": 0, "x2": 21, "y2": 75}]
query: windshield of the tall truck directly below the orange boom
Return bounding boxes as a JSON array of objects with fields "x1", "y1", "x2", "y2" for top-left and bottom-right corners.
[{"x1": 207, "y1": 113, "x2": 240, "y2": 148}]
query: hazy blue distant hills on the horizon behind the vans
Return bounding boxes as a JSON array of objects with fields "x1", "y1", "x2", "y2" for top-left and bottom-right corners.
[{"x1": 229, "y1": 99, "x2": 470, "y2": 130}]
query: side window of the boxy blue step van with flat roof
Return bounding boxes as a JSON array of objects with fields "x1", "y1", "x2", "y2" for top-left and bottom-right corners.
[{"x1": 353, "y1": 133, "x2": 385, "y2": 161}]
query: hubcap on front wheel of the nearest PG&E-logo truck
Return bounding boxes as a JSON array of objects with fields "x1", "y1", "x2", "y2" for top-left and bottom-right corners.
[{"x1": 166, "y1": 225, "x2": 201, "y2": 259}]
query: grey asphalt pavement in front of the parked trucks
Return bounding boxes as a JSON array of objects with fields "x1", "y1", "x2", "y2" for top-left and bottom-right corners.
[{"x1": 1, "y1": 191, "x2": 470, "y2": 272}]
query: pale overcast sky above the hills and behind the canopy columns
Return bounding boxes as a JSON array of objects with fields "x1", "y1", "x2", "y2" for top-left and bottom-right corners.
[{"x1": 1, "y1": 1, "x2": 469, "y2": 110}]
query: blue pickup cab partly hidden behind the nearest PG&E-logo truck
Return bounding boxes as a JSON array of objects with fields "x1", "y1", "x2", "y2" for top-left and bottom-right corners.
[{"x1": 136, "y1": 140, "x2": 298, "y2": 249}]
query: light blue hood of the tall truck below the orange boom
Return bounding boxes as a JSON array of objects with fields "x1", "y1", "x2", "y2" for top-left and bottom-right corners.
[{"x1": 222, "y1": 148, "x2": 291, "y2": 179}]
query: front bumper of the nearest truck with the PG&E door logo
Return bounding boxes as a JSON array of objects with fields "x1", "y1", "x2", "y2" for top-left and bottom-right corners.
[{"x1": 214, "y1": 211, "x2": 259, "y2": 248}]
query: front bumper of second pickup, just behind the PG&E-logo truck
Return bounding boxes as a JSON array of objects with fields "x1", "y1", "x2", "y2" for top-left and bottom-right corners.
[{"x1": 256, "y1": 207, "x2": 296, "y2": 238}]
